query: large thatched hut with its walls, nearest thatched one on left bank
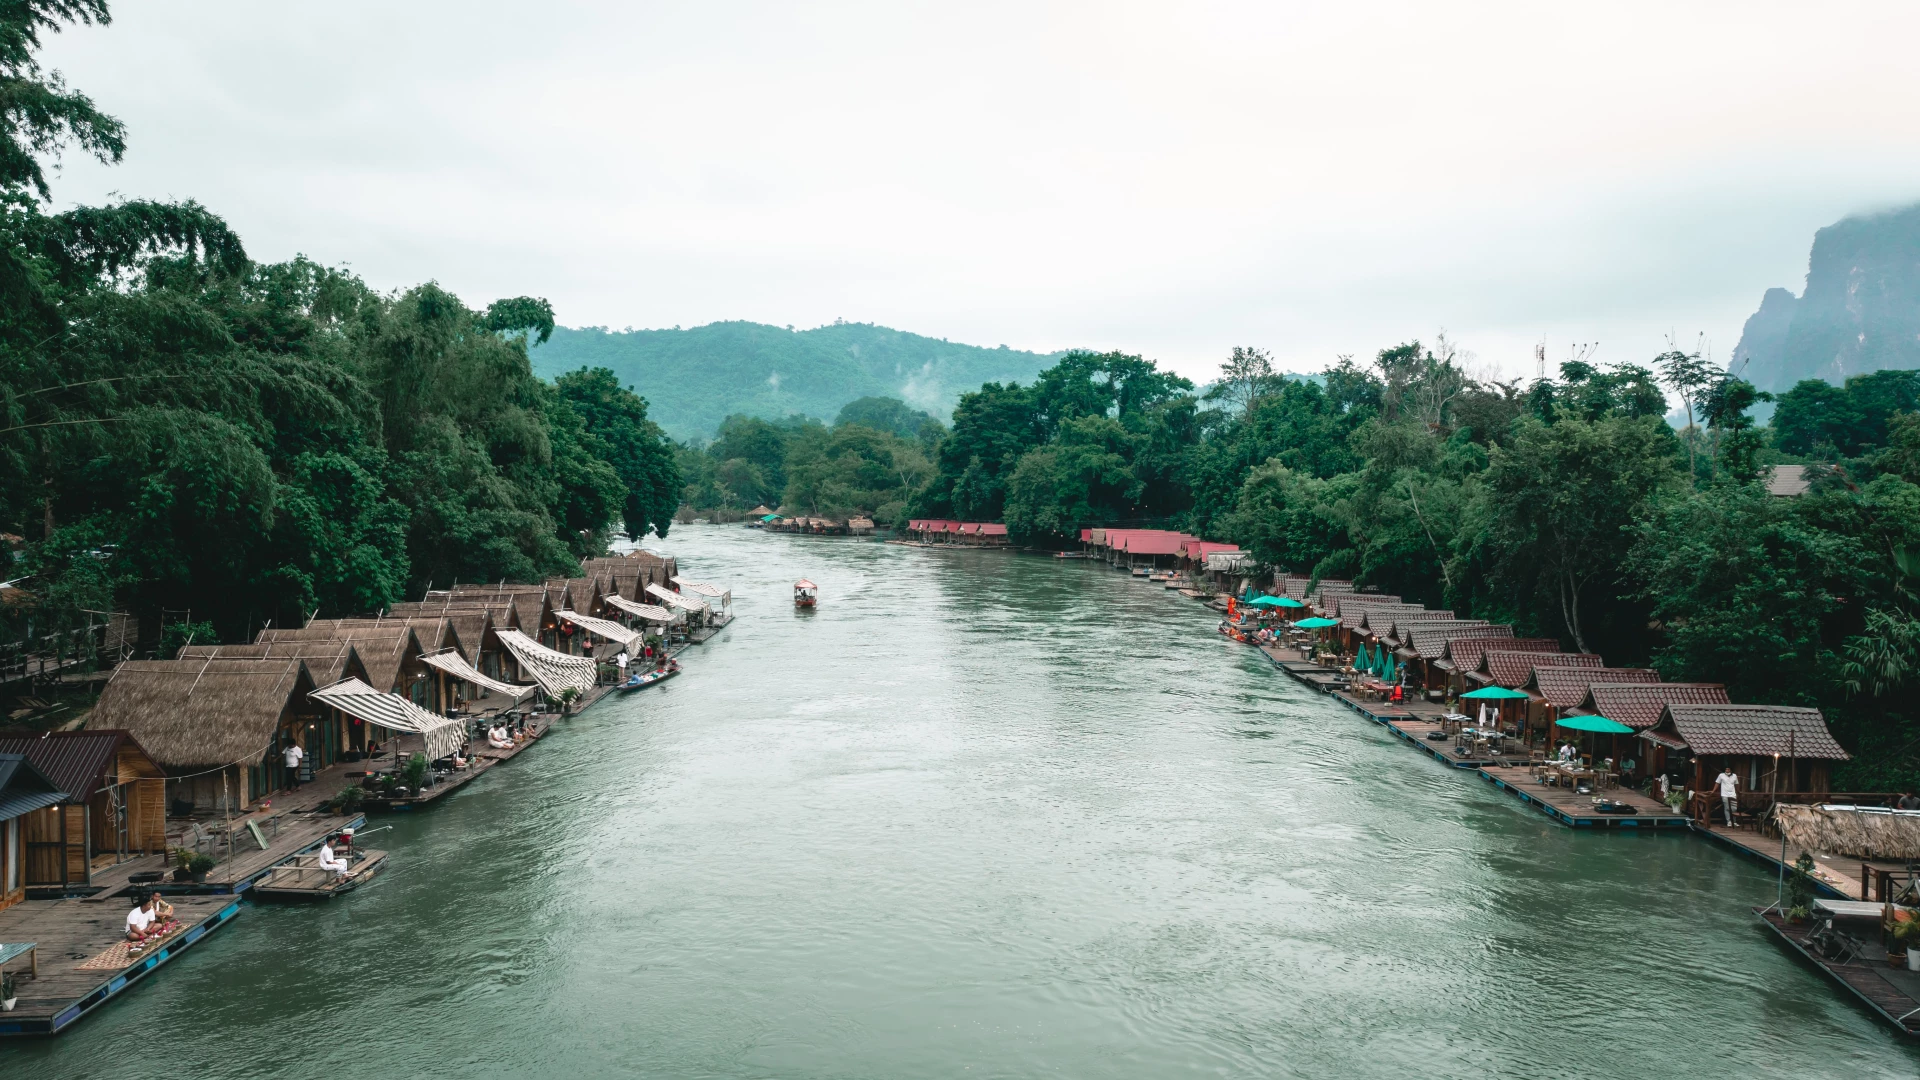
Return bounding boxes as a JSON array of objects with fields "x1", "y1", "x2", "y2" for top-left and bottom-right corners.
[{"x1": 90, "y1": 657, "x2": 320, "y2": 811}]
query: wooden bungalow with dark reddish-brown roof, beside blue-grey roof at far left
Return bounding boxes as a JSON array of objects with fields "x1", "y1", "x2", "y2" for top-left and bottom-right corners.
[{"x1": 0, "y1": 728, "x2": 167, "y2": 888}]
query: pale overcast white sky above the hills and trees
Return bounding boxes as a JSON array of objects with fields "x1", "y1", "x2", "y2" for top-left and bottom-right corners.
[{"x1": 46, "y1": 0, "x2": 1920, "y2": 377}]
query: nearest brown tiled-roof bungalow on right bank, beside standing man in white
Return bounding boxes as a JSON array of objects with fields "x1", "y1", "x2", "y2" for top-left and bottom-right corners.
[{"x1": 1640, "y1": 701, "x2": 1851, "y2": 809}]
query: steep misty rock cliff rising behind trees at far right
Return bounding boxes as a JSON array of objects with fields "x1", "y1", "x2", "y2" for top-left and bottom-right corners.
[{"x1": 1732, "y1": 206, "x2": 1920, "y2": 392}]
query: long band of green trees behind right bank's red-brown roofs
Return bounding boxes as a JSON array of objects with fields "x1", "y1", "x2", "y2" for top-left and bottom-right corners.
[{"x1": 714, "y1": 340, "x2": 1920, "y2": 790}]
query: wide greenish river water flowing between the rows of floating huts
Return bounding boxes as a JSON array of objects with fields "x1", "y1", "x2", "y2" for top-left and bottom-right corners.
[{"x1": 0, "y1": 527, "x2": 1920, "y2": 1080}]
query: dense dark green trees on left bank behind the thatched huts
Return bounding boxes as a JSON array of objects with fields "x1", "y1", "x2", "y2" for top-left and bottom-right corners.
[{"x1": 0, "y1": 0, "x2": 682, "y2": 640}]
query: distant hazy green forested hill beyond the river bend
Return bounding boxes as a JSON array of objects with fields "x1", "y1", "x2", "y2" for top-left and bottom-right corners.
[{"x1": 532, "y1": 323, "x2": 1058, "y2": 440}]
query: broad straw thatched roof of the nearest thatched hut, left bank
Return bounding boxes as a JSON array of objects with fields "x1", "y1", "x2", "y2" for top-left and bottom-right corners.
[{"x1": 88, "y1": 657, "x2": 313, "y2": 769}]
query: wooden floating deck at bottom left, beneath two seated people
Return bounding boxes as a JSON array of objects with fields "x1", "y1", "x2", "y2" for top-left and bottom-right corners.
[{"x1": 0, "y1": 894, "x2": 240, "y2": 1036}]
